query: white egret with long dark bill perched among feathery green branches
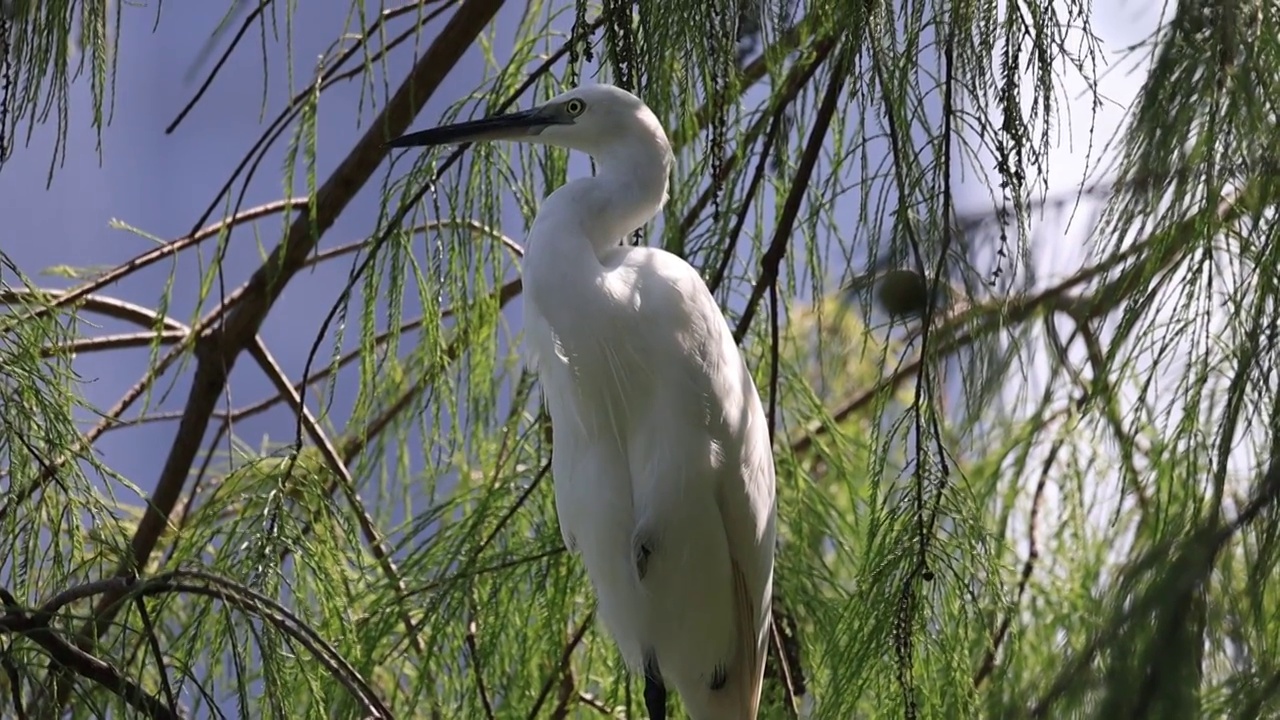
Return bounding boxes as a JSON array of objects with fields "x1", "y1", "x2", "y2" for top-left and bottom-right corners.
[{"x1": 389, "y1": 85, "x2": 776, "y2": 720}]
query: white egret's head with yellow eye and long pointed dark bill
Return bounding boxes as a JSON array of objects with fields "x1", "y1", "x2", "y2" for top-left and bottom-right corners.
[{"x1": 387, "y1": 85, "x2": 671, "y2": 159}]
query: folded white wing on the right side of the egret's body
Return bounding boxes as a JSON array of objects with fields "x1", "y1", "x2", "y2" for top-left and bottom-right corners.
[{"x1": 601, "y1": 243, "x2": 774, "y2": 720}]
